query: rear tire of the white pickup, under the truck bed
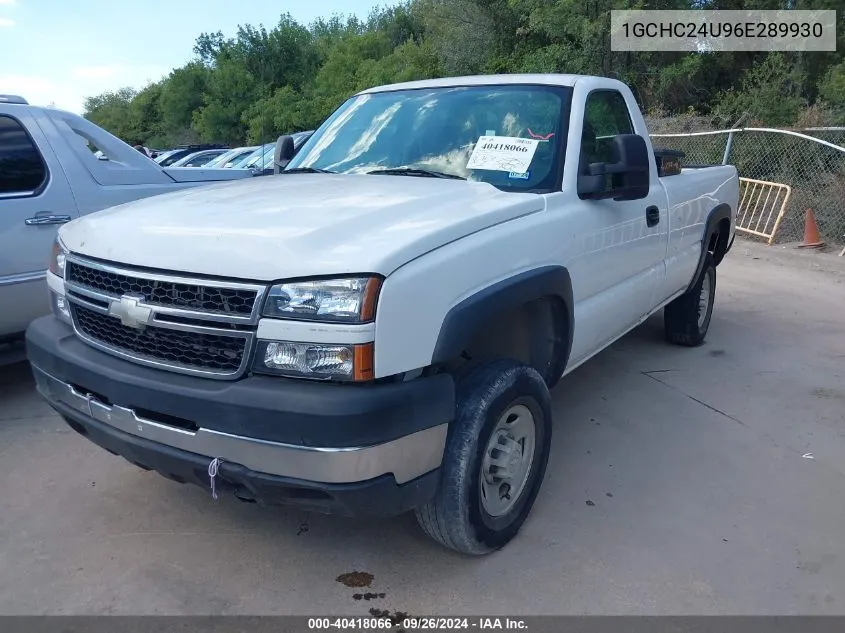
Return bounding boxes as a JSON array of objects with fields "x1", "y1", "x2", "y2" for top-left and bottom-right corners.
[{"x1": 663, "y1": 253, "x2": 716, "y2": 347}]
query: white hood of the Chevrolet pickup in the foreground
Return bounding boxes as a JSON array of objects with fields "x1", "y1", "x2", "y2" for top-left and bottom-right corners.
[{"x1": 60, "y1": 170, "x2": 545, "y2": 281}]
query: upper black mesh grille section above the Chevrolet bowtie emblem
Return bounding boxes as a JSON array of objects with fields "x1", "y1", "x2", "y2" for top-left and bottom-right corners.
[{"x1": 65, "y1": 261, "x2": 258, "y2": 316}]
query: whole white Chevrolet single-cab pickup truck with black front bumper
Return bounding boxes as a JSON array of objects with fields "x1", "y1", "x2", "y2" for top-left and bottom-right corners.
[{"x1": 27, "y1": 75, "x2": 738, "y2": 554}]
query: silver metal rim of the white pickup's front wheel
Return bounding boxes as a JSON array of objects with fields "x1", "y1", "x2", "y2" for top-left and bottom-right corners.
[{"x1": 479, "y1": 404, "x2": 536, "y2": 517}]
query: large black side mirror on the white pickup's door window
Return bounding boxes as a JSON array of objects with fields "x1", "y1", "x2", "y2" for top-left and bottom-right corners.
[{"x1": 578, "y1": 134, "x2": 651, "y2": 201}]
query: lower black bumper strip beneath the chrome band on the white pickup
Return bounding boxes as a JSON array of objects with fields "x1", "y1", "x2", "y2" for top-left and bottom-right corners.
[{"x1": 51, "y1": 403, "x2": 440, "y2": 517}]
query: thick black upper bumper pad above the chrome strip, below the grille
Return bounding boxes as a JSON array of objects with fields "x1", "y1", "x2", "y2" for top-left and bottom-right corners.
[{"x1": 26, "y1": 316, "x2": 455, "y2": 448}]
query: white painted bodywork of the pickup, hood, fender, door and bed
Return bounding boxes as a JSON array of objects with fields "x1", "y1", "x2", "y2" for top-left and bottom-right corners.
[{"x1": 56, "y1": 75, "x2": 739, "y2": 377}]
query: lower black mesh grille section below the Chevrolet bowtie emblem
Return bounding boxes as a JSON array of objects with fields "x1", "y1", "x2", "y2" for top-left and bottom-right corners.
[{"x1": 70, "y1": 302, "x2": 247, "y2": 374}]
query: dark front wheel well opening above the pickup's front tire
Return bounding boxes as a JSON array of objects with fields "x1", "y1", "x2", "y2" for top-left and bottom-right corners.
[{"x1": 446, "y1": 296, "x2": 570, "y2": 387}]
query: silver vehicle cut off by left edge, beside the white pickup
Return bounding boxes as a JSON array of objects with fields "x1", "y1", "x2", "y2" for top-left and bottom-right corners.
[{"x1": 0, "y1": 95, "x2": 253, "y2": 364}]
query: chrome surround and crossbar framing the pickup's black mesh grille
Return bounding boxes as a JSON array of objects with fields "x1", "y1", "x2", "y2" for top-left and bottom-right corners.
[{"x1": 64, "y1": 254, "x2": 267, "y2": 380}]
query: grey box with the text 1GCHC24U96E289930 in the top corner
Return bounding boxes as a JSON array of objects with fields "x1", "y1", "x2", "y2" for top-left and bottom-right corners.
[{"x1": 610, "y1": 10, "x2": 836, "y2": 53}]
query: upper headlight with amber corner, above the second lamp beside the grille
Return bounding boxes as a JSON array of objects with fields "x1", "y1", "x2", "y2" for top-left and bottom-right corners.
[{"x1": 264, "y1": 277, "x2": 381, "y2": 323}]
